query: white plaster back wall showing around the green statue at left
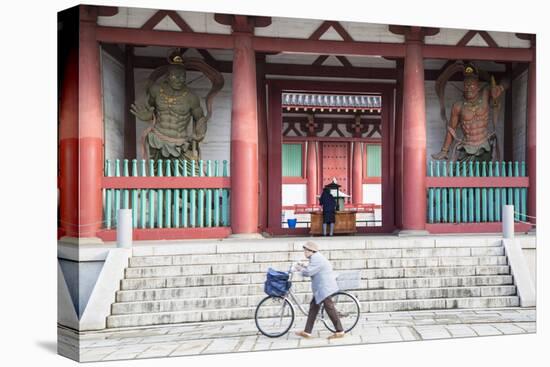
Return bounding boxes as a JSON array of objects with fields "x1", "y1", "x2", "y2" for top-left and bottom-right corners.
[{"x1": 134, "y1": 69, "x2": 232, "y2": 173}]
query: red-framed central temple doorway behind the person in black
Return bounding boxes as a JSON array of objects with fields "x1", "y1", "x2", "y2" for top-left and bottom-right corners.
[{"x1": 266, "y1": 80, "x2": 395, "y2": 235}]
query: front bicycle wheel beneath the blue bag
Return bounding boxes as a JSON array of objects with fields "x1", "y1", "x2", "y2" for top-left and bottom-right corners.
[{"x1": 254, "y1": 296, "x2": 294, "y2": 338}]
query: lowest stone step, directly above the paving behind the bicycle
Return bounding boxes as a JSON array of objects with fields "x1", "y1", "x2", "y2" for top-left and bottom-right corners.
[{"x1": 107, "y1": 296, "x2": 519, "y2": 328}]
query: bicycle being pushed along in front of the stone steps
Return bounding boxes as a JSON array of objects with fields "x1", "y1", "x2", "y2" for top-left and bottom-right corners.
[{"x1": 254, "y1": 263, "x2": 361, "y2": 338}]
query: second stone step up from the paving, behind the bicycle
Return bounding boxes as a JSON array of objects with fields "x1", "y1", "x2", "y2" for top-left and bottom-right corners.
[{"x1": 111, "y1": 286, "x2": 516, "y2": 315}]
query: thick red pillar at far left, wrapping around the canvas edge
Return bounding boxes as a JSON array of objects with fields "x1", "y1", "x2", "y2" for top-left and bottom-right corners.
[{"x1": 59, "y1": 5, "x2": 103, "y2": 238}]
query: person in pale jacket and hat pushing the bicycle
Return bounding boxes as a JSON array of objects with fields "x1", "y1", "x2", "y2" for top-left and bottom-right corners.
[{"x1": 296, "y1": 241, "x2": 345, "y2": 339}]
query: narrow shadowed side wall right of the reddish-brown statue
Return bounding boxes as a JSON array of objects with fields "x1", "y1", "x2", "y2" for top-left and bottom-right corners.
[{"x1": 512, "y1": 71, "x2": 528, "y2": 161}]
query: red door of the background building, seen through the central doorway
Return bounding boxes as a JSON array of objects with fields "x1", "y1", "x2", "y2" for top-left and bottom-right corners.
[{"x1": 321, "y1": 142, "x2": 349, "y2": 195}]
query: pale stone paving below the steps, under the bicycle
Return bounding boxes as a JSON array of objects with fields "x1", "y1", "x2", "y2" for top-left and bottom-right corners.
[{"x1": 58, "y1": 308, "x2": 536, "y2": 362}]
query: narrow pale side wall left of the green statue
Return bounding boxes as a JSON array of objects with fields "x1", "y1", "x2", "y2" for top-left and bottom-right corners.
[{"x1": 101, "y1": 51, "x2": 124, "y2": 159}]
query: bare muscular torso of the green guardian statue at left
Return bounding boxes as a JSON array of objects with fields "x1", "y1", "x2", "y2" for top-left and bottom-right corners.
[{"x1": 149, "y1": 82, "x2": 202, "y2": 139}]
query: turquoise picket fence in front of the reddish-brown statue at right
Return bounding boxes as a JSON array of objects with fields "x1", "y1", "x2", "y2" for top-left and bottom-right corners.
[{"x1": 428, "y1": 161, "x2": 527, "y2": 223}]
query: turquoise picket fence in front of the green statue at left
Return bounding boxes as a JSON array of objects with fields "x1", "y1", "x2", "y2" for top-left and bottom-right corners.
[{"x1": 103, "y1": 159, "x2": 230, "y2": 229}]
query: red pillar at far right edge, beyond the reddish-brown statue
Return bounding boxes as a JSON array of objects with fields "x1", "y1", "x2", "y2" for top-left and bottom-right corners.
[{"x1": 527, "y1": 40, "x2": 537, "y2": 224}]
